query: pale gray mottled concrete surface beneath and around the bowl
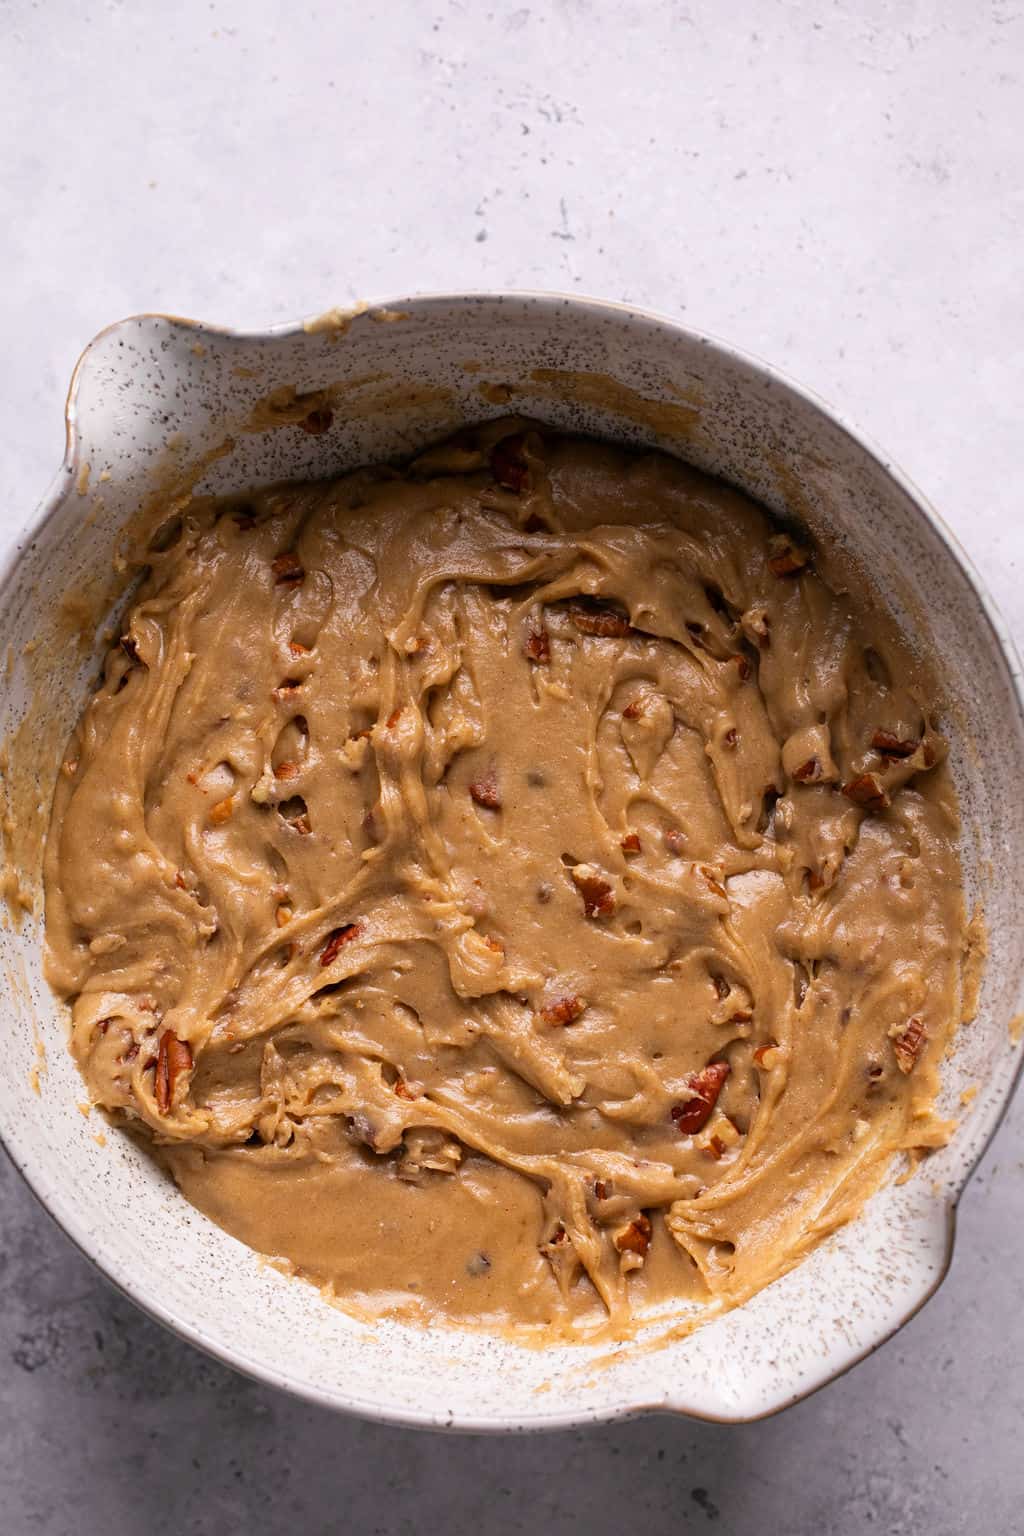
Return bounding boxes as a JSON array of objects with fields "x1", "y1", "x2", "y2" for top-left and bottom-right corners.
[{"x1": 0, "y1": 0, "x2": 1024, "y2": 1536}]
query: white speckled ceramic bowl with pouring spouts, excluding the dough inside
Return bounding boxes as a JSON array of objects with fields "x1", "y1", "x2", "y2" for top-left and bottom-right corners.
[{"x1": 0, "y1": 295, "x2": 1024, "y2": 1428}]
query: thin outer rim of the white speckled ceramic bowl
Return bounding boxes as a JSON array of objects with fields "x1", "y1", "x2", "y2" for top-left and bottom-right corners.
[{"x1": 0, "y1": 289, "x2": 1024, "y2": 1433}]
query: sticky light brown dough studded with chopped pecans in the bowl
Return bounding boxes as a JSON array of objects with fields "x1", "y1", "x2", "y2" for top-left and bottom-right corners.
[{"x1": 46, "y1": 419, "x2": 964, "y2": 1333}]
